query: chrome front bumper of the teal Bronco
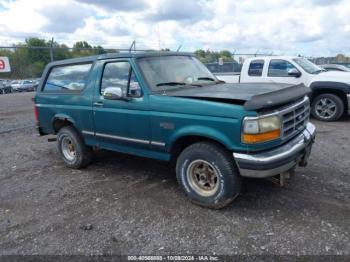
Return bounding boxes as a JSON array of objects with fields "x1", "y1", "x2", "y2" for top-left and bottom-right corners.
[{"x1": 233, "y1": 123, "x2": 316, "y2": 178}]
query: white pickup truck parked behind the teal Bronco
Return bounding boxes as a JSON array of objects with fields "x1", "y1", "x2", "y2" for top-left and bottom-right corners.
[{"x1": 215, "y1": 56, "x2": 350, "y2": 121}]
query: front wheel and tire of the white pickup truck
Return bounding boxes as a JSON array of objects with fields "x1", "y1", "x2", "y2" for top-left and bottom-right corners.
[{"x1": 311, "y1": 94, "x2": 344, "y2": 121}]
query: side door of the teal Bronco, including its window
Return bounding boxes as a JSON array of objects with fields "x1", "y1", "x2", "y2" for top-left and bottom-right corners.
[{"x1": 93, "y1": 59, "x2": 151, "y2": 149}]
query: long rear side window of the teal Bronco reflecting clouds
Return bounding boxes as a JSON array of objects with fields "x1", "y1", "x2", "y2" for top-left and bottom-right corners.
[{"x1": 44, "y1": 64, "x2": 92, "y2": 92}]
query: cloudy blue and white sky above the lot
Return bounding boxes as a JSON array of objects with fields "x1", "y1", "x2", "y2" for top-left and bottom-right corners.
[{"x1": 0, "y1": 0, "x2": 350, "y2": 56}]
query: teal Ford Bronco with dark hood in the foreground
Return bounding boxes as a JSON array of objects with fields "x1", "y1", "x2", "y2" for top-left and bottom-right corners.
[{"x1": 34, "y1": 52, "x2": 315, "y2": 208}]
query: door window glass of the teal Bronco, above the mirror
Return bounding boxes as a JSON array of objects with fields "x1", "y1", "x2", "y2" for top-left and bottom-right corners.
[{"x1": 100, "y1": 61, "x2": 142, "y2": 97}]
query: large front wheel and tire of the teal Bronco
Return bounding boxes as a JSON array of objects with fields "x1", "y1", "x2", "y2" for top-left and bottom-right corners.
[{"x1": 176, "y1": 142, "x2": 242, "y2": 209}]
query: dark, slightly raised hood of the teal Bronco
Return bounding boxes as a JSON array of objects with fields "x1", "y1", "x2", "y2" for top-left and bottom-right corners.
[{"x1": 163, "y1": 83, "x2": 310, "y2": 110}]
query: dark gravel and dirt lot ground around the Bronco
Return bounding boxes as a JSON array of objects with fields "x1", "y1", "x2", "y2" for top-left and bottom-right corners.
[{"x1": 0, "y1": 93, "x2": 350, "y2": 255}]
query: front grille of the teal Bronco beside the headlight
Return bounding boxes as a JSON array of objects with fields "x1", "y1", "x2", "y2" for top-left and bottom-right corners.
[{"x1": 280, "y1": 97, "x2": 310, "y2": 140}]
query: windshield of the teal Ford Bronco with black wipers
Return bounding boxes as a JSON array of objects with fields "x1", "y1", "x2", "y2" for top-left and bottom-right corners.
[{"x1": 138, "y1": 55, "x2": 218, "y2": 92}]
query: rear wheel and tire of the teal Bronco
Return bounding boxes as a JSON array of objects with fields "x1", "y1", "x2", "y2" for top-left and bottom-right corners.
[{"x1": 57, "y1": 126, "x2": 92, "y2": 169}]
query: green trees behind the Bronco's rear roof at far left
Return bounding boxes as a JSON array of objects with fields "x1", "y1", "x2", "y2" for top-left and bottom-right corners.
[{"x1": 0, "y1": 37, "x2": 106, "y2": 79}]
